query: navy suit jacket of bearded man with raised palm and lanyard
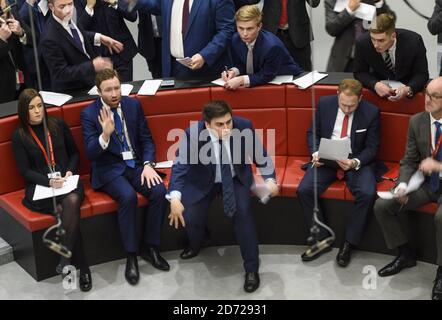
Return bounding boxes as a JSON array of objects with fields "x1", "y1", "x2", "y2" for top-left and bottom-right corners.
[{"x1": 80, "y1": 97, "x2": 155, "y2": 189}]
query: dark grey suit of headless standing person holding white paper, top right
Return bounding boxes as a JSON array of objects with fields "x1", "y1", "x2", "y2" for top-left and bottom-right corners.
[{"x1": 324, "y1": 0, "x2": 394, "y2": 72}]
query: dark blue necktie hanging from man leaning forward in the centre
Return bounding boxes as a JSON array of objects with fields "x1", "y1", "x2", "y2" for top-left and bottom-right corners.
[{"x1": 219, "y1": 140, "x2": 236, "y2": 218}]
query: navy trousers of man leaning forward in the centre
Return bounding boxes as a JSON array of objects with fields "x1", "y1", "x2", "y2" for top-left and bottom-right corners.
[{"x1": 184, "y1": 178, "x2": 259, "y2": 272}]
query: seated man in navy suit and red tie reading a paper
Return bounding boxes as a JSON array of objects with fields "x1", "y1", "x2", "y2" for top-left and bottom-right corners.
[{"x1": 297, "y1": 79, "x2": 380, "y2": 267}]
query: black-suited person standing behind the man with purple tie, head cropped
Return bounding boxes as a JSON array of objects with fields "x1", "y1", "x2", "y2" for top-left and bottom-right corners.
[{"x1": 78, "y1": 0, "x2": 137, "y2": 82}]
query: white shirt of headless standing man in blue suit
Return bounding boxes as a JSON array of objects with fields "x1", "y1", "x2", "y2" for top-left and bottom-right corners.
[{"x1": 170, "y1": 0, "x2": 193, "y2": 58}]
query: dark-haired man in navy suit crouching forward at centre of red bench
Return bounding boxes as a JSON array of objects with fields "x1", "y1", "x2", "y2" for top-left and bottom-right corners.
[{"x1": 168, "y1": 101, "x2": 278, "y2": 292}]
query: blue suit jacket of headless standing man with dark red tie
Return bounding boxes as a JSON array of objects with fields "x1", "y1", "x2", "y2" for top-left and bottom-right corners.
[{"x1": 136, "y1": 0, "x2": 235, "y2": 77}]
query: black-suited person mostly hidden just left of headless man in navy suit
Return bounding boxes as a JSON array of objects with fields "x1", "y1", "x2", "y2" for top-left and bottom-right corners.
[{"x1": 138, "y1": 11, "x2": 163, "y2": 79}]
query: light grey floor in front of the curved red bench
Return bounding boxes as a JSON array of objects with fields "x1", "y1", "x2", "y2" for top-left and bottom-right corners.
[{"x1": 0, "y1": 246, "x2": 436, "y2": 300}]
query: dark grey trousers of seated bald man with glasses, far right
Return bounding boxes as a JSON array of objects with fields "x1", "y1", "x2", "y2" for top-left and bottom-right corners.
[{"x1": 374, "y1": 183, "x2": 442, "y2": 266}]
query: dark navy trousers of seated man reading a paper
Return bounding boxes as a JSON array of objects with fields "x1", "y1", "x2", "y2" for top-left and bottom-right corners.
[{"x1": 297, "y1": 166, "x2": 376, "y2": 246}]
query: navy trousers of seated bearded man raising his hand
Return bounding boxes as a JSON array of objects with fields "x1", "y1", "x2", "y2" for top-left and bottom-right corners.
[{"x1": 101, "y1": 165, "x2": 168, "y2": 252}]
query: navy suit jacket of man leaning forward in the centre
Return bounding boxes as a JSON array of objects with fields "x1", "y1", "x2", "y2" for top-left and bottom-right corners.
[{"x1": 169, "y1": 117, "x2": 275, "y2": 205}]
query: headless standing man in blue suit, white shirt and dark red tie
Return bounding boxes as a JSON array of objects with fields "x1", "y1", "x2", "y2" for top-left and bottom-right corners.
[{"x1": 130, "y1": 0, "x2": 235, "y2": 78}]
